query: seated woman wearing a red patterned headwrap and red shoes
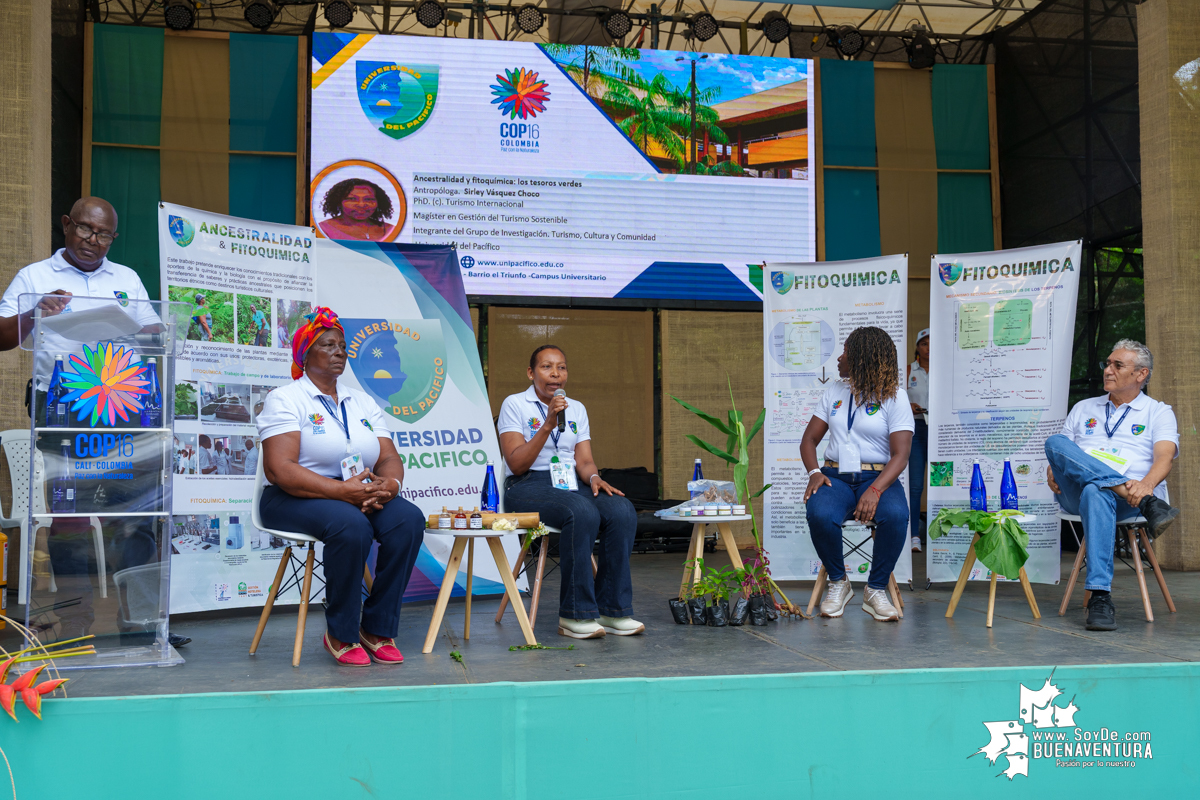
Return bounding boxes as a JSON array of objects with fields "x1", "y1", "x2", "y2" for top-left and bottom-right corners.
[{"x1": 257, "y1": 307, "x2": 425, "y2": 667}]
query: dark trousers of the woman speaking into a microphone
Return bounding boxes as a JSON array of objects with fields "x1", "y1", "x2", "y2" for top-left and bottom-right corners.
[{"x1": 504, "y1": 470, "x2": 637, "y2": 619}]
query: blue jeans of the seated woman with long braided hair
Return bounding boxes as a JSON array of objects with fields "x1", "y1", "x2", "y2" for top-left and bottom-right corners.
[{"x1": 805, "y1": 467, "x2": 908, "y2": 589}]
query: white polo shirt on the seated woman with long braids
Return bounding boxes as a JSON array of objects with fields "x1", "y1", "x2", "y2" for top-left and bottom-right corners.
[{"x1": 812, "y1": 380, "x2": 917, "y2": 464}]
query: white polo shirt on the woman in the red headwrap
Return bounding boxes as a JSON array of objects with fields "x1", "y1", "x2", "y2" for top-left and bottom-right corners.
[{"x1": 257, "y1": 375, "x2": 391, "y2": 483}]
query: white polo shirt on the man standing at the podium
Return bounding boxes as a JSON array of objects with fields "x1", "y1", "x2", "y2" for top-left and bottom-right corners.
[{"x1": 0, "y1": 249, "x2": 162, "y2": 389}]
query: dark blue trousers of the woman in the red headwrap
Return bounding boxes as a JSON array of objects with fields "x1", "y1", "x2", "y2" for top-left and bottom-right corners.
[{"x1": 258, "y1": 486, "x2": 425, "y2": 644}]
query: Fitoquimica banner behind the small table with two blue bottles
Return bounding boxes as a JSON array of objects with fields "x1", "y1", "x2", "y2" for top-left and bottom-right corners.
[{"x1": 925, "y1": 241, "x2": 1081, "y2": 583}]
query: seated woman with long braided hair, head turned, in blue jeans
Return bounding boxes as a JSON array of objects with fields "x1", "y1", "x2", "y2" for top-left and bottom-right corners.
[{"x1": 800, "y1": 327, "x2": 914, "y2": 622}]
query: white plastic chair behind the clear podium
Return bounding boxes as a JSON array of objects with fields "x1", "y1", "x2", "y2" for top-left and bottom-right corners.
[{"x1": 0, "y1": 428, "x2": 108, "y2": 604}]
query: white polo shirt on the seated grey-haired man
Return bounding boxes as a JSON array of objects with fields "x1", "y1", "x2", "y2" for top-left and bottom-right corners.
[{"x1": 1062, "y1": 392, "x2": 1180, "y2": 499}]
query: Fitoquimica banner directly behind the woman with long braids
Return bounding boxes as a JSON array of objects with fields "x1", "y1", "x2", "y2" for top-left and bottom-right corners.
[{"x1": 762, "y1": 255, "x2": 912, "y2": 582}]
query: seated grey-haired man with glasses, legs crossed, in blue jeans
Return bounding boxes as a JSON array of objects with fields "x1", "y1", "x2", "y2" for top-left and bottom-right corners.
[{"x1": 1045, "y1": 339, "x2": 1180, "y2": 631}]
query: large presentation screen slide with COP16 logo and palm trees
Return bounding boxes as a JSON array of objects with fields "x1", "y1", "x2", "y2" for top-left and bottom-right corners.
[{"x1": 310, "y1": 32, "x2": 816, "y2": 301}]
